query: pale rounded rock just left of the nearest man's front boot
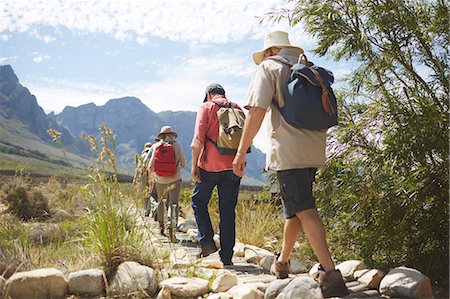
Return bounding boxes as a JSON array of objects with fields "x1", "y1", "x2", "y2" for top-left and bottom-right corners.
[{"x1": 276, "y1": 276, "x2": 323, "y2": 299}]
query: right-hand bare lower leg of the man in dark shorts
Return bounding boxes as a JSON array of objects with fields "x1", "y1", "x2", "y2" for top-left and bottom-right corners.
[{"x1": 295, "y1": 209, "x2": 334, "y2": 272}]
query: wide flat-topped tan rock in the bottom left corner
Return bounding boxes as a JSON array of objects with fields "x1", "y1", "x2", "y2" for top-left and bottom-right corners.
[{"x1": 5, "y1": 268, "x2": 69, "y2": 299}]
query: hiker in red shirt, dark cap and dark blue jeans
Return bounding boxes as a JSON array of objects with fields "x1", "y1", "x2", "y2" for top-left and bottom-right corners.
[{"x1": 191, "y1": 84, "x2": 241, "y2": 265}]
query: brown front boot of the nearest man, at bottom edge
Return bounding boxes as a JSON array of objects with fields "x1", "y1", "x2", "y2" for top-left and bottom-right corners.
[{"x1": 314, "y1": 267, "x2": 349, "y2": 298}]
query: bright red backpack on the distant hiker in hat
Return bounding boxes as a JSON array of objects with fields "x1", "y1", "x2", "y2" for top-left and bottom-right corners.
[{"x1": 153, "y1": 142, "x2": 177, "y2": 176}]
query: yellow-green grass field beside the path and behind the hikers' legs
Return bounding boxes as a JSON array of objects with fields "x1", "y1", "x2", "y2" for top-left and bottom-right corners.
[{"x1": 0, "y1": 128, "x2": 316, "y2": 296}]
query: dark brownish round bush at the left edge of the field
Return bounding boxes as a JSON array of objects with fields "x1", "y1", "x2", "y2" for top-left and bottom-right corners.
[{"x1": 0, "y1": 170, "x2": 50, "y2": 221}]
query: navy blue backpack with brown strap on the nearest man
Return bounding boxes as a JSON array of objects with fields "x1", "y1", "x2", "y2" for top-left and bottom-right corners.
[{"x1": 269, "y1": 55, "x2": 338, "y2": 130}]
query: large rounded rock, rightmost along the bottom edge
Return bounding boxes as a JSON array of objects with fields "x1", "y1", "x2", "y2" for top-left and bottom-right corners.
[{"x1": 380, "y1": 267, "x2": 432, "y2": 298}]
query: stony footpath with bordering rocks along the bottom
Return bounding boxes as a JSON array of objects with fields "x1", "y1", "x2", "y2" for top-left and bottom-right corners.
[{"x1": 0, "y1": 220, "x2": 432, "y2": 299}]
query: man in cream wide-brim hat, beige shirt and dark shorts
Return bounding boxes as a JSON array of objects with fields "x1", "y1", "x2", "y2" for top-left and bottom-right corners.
[{"x1": 233, "y1": 31, "x2": 348, "y2": 297}]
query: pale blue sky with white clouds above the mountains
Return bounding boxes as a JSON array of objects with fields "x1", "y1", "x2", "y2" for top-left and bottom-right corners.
[{"x1": 0, "y1": 0, "x2": 356, "y2": 152}]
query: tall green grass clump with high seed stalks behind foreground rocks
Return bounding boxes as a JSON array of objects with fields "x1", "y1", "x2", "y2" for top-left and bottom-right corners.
[{"x1": 82, "y1": 125, "x2": 154, "y2": 275}]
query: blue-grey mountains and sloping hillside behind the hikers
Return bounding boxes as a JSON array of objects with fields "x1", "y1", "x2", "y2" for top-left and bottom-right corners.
[{"x1": 0, "y1": 65, "x2": 265, "y2": 185}]
